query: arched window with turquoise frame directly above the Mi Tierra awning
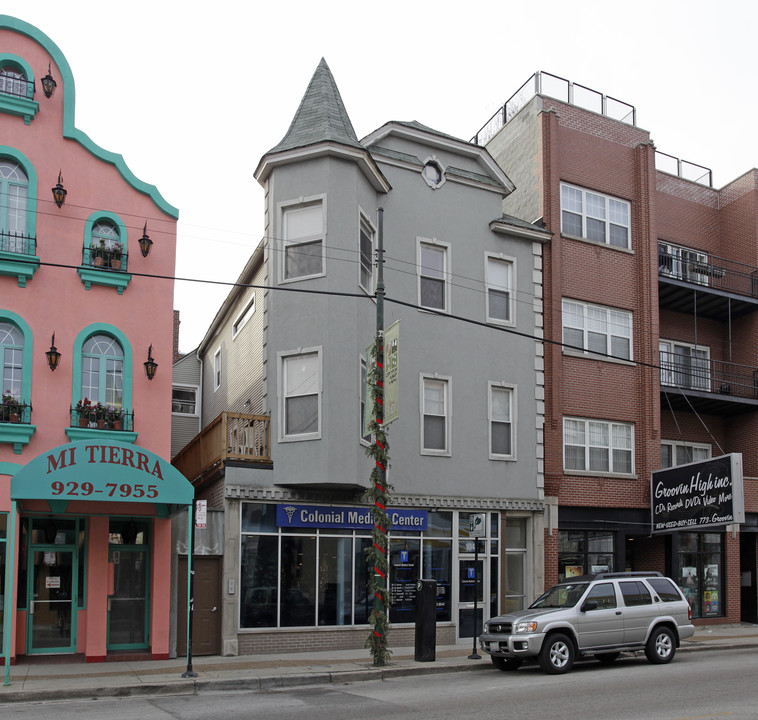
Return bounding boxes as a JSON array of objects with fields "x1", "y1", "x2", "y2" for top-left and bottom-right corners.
[{"x1": 81, "y1": 334, "x2": 124, "y2": 408}]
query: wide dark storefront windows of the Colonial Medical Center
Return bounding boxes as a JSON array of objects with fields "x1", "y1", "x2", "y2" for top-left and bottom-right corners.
[{"x1": 240, "y1": 503, "x2": 453, "y2": 629}]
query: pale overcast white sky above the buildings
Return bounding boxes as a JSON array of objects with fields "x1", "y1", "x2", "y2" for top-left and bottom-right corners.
[{"x1": 16, "y1": 0, "x2": 758, "y2": 352}]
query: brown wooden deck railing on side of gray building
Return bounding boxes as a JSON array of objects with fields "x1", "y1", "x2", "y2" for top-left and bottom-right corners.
[{"x1": 172, "y1": 412, "x2": 271, "y2": 481}]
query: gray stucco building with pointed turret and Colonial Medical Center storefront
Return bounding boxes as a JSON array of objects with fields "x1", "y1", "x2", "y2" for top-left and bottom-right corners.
[{"x1": 174, "y1": 60, "x2": 549, "y2": 654}]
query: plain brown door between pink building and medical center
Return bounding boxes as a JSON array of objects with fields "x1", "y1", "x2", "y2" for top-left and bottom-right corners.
[{"x1": 176, "y1": 555, "x2": 221, "y2": 656}]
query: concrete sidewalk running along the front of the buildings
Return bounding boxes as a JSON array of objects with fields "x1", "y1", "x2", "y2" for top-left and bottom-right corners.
[{"x1": 0, "y1": 623, "x2": 758, "y2": 704}]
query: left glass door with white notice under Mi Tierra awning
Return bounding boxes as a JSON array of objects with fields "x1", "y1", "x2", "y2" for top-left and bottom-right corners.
[{"x1": 27, "y1": 545, "x2": 76, "y2": 654}]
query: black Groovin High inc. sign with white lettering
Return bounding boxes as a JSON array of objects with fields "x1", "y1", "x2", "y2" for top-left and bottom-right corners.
[{"x1": 650, "y1": 453, "x2": 745, "y2": 533}]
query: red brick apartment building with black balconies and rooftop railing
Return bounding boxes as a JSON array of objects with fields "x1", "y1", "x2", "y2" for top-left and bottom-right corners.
[{"x1": 475, "y1": 73, "x2": 758, "y2": 622}]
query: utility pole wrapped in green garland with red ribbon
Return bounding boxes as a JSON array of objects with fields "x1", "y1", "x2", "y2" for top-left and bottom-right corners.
[{"x1": 367, "y1": 208, "x2": 390, "y2": 666}]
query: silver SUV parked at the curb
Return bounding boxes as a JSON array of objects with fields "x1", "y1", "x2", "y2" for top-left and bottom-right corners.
[{"x1": 479, "y1": 572, "x2": 695, "y2": 674}]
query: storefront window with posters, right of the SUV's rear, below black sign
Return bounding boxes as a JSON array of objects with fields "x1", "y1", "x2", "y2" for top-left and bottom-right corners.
[{"x1": 677, "y1": 533, "x2": 724, "y2": 618}]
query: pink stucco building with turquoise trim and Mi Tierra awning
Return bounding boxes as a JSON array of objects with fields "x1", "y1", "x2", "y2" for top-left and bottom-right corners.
[{"x1": 0, "y1": 15, "x2": 191, "y2": 662}]
